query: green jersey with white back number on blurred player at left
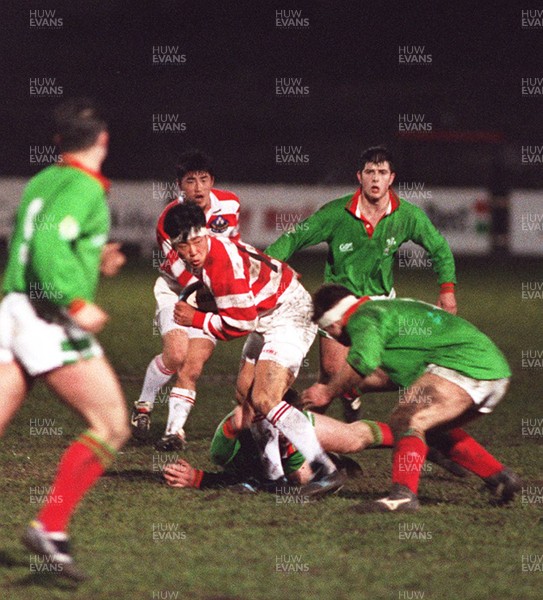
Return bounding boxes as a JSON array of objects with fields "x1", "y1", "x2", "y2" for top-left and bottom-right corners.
[{"x1": 3, "y1": 162, "x2": 110, "y2": 306}]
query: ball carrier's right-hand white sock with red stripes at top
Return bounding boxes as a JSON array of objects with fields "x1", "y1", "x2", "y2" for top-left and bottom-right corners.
[{"x1": 266, "y1": 401, "x2": 336, "y2": 474}]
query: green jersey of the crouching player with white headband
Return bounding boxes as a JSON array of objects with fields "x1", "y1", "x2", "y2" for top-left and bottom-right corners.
[{"x1": 346, "y1": 299, "x2": 511, "y2": 387}]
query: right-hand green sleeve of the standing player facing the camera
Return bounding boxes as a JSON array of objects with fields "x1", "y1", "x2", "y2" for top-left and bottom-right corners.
[{"x1": 412, "y1": 206, "x2": 456, "y2": 284}]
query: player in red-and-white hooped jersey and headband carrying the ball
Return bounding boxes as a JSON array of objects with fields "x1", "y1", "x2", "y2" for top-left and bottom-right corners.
[{"x1": 169, "y1": 203, "x2": 344, "y2": 495}]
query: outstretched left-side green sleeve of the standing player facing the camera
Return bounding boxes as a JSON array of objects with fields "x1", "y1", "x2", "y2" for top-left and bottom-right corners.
[{"x1": 264, "y1": 204, "x2": 333, "y2": 262}]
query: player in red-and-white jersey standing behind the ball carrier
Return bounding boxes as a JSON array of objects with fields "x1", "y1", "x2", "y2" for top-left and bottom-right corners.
[{"x1": 131, "y1": 151, "x2": 239, "y2": 451}]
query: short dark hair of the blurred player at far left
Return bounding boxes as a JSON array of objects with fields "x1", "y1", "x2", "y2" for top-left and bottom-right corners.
[{"x1": 53, "y1": 98, "x2": 107, "y2": 152}]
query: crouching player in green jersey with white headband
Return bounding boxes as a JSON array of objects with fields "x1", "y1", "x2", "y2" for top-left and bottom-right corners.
[{"x1": 302, "y1": 284, "x2": 521, "y2": 511}]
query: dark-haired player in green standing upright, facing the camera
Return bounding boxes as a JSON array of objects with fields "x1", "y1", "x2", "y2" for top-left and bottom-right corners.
[{"x1": 265, "y1": 147, "x2": 456, "y2": 420}]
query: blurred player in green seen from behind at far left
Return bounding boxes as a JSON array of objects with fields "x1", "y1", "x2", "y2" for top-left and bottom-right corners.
[{"x1": 0, "y1": 100, "x2": 130, "y2": 580}]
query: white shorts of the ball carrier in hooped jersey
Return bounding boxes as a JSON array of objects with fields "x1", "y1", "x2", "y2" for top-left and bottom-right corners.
[{"x1": 241, "y1": 278, "x2": 317, "y2": 377}]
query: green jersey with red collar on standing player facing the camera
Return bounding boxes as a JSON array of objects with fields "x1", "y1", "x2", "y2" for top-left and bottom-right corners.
[{"x1": 264, "y1": 190, "x2": 456, "y2": 296}]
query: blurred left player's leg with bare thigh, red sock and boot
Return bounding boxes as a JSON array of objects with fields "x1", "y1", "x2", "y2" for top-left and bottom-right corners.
[{"x1": 23, "y1": 358, "x2": 130, "y2": 579}]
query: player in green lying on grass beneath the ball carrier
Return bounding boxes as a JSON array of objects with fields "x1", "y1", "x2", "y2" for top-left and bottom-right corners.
[{"x1": 164, "y1": 400, "x2": 393, "y2": 492}]
